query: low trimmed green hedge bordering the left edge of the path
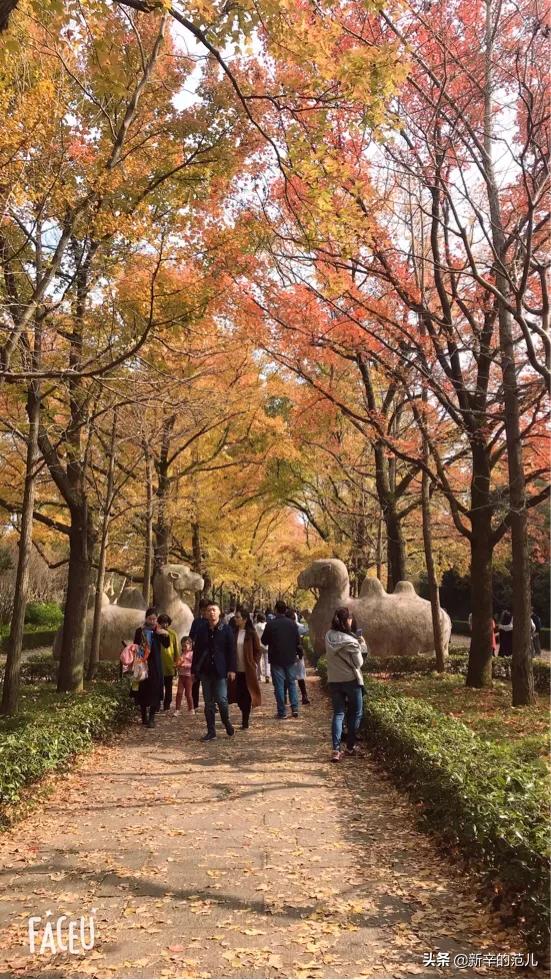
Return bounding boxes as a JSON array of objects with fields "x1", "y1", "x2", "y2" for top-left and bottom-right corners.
[{"x1": 0, "y1": 684, "x2": 134, "y2": 825}]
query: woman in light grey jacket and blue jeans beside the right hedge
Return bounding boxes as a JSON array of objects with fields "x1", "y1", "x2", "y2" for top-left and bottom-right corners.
[{"x1": 325, "y1": 606, "x2": 367, "y2": 762}]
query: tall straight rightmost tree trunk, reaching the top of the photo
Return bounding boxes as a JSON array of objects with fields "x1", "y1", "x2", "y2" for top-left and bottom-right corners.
[{"x1": 484, "y1": 0, "x2": 535, "y2": 707}]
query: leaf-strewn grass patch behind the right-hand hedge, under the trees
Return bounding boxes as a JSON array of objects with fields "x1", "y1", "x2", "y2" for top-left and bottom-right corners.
[{"x1": 374, "y1": 674, "x2": 549, "y2": 770}]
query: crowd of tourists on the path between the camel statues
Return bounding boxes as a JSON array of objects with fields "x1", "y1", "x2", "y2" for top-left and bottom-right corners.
[{"x1": 121, "y1": 599, "x2": 367, "y2": 762}]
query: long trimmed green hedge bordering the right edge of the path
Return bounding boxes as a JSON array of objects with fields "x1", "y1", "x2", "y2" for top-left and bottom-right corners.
[{"x1": 318, "y1": 659, "x2": 549, "y2": 952}]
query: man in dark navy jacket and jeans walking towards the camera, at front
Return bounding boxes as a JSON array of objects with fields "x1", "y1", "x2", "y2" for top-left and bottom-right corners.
[{"x1": 191, "y1": 602, "x2": 236, "y2": 742}]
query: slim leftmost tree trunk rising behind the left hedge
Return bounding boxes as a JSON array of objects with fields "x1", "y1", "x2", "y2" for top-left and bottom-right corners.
[{"x1": 0, "y1": 384, "x2": 40, "y2": 715}]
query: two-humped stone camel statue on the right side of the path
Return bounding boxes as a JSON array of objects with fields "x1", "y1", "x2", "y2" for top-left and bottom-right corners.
[{"x1": 298, "y1": 558, "x2": 452, "y2": 657}]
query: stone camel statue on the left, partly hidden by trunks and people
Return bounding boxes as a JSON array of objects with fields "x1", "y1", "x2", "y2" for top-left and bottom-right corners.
[{"x1": 53, "y1": 565, "x2": 203, "y2": 660}]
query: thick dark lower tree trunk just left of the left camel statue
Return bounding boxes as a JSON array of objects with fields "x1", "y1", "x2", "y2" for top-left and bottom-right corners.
[{"x1": 57, "y1": 504, "x2": 94, "y2": 691}]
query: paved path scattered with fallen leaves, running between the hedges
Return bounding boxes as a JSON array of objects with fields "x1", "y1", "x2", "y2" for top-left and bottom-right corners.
[{"x1": 0, "y1": 680, "x2": 534, "y2": 977}]
